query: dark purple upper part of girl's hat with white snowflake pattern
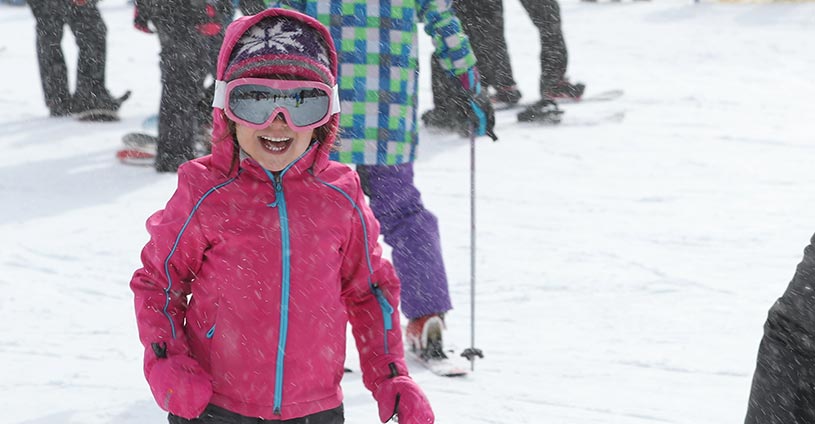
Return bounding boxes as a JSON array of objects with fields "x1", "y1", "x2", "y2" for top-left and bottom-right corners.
[{"x1": 230, "y1": 19, "x2": 330, "y2": 68}]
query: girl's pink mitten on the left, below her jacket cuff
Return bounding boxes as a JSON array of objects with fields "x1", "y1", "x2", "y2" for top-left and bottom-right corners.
[{"x1": 147, "y1": 355, "x2": 212, "y2": 419}]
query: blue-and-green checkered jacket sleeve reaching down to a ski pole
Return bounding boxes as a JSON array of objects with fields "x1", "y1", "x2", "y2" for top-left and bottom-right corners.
[{"x1": 416, "y1": 0, "x2": 476, "y2": 76}]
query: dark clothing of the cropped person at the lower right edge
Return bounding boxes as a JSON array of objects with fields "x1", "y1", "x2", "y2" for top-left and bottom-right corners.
[{"x1": 745, "y1": 232, "x2": 815, "y2": 424}]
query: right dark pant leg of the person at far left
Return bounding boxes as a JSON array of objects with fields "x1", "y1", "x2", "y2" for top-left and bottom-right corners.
[{"x1": 68, "y1": 2, "x2": 111, "y2": 106}]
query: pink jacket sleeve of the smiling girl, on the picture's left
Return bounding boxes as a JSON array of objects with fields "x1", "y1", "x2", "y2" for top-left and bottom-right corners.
[{"x1": 130, "y1": 167, "x2": 206, "y2": 376}]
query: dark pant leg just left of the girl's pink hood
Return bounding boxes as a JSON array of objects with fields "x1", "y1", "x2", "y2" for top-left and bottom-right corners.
[{"x1": 150, "y1": 6, "x2": 208, "y2": 172}]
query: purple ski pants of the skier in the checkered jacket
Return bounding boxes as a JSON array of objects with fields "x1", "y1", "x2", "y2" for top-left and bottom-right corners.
[{"x1": 357, "y1": 163, "x2": 453, "y2": 319}]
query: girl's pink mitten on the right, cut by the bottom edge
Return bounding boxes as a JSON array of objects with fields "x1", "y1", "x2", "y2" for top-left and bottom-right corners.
[{"x1": 374, "y1": 375, "x2": 436, "y2": 424}]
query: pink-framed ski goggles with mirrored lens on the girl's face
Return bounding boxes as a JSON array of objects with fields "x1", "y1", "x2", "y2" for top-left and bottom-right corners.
[{"x1": 212, "y1": 78, "x2": 340, "y2": 131}]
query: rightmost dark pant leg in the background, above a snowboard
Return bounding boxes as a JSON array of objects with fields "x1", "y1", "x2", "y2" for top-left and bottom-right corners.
[{"x1": 521, "y1": 0, "x2": 569, "y2": 96}]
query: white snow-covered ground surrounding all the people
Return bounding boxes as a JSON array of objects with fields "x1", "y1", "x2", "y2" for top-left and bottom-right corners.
[{"x1": 0, "y1": 0, "x2": 815, "y2": 424}]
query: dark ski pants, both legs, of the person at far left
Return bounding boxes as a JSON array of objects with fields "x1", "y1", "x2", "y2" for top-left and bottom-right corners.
[{"x1": 28, "y1": 0, "x2": 109, "y2": 115}]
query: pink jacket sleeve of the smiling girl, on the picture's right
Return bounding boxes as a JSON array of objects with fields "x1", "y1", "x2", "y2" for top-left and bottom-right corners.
[{"x1": 341, "y1": 174, "x2": 408, "y2": 393}]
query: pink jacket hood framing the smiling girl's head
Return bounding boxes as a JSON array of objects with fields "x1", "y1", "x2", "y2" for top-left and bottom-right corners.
[{"x1": 212, "y1": 8, "x2": 339, "y2": 176}]
